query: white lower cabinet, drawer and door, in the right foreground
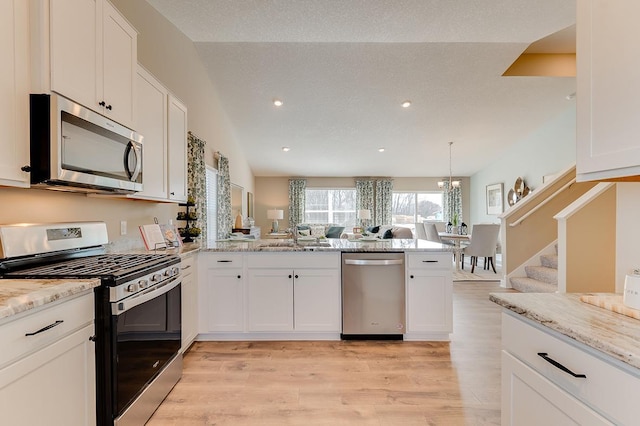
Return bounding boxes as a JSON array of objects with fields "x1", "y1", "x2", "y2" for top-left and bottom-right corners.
[{"x1": 502, "y1": 311, "x2": 640, "y2": 426}]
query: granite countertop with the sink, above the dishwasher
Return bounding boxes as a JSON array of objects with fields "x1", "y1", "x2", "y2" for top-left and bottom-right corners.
[{"x1": 201, "y1": 238, "x2": 453, "y2": 252}]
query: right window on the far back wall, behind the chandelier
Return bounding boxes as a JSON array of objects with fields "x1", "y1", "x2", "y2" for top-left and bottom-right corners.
[{"x1": 391, "y1": 191, "x2": 444, "y2": 231}]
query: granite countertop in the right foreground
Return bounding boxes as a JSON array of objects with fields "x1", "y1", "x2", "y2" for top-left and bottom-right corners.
[{"x1": 489, "y1": 293, "x2": 640, "y2": 368}]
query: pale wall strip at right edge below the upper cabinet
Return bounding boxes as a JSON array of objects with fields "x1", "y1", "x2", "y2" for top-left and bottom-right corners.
[{"x1": 616, "y1": 182, "x2": 640, "y2": 293}]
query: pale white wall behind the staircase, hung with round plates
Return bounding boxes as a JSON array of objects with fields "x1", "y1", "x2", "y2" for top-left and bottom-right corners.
[{"x1": 470, "y1": 103, "x2": 576, "y2": 223}]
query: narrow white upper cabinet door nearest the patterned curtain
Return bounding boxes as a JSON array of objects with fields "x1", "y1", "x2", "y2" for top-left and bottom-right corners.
[{"x1": 168, "y1": 95, "x2": 187, "y2": 203}]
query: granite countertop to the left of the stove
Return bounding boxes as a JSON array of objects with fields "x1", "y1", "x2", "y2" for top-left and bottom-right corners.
[{"x1": 0, "y1": 279, "x2": 100, "y2": 321}]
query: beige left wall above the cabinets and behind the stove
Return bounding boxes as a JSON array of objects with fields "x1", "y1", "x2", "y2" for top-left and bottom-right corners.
[{"x1": 0, "y1": 0, "x2": 254, "y2": 245}]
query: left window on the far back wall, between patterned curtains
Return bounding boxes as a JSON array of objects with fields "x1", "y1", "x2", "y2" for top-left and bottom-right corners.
[{"x1": 304, "y1": 189, "x2": 356, "y2": 228}]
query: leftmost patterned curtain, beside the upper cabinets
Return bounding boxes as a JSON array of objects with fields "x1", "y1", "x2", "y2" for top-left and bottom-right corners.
[{"x1": 187, "y1": 132, "x2": 207, "y2": 244}]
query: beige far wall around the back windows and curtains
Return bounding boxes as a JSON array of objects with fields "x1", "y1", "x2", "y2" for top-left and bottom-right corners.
[{"x1": 254, "y1": 177, "x2": 469, "y2": 233}]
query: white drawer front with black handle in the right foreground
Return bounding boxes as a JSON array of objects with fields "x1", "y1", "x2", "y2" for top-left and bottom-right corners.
[{"x1": 502, "y1": 313, "x2": 640, "y2": 424}]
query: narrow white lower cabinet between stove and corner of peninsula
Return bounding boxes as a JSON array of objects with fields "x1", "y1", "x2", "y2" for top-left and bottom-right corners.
[{"x1": 180, "y1": 255, "x2": 198, "y2": 352}]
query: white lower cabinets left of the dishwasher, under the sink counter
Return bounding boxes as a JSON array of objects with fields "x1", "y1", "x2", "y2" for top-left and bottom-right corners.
[{"x1": 199, "y1": 252, "x2": 342, "y2": 340}]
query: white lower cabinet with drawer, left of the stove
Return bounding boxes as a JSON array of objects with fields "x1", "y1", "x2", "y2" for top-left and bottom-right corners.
[{"x1": 0, "y1": 293, "x2": 96, "y2": 426}]
